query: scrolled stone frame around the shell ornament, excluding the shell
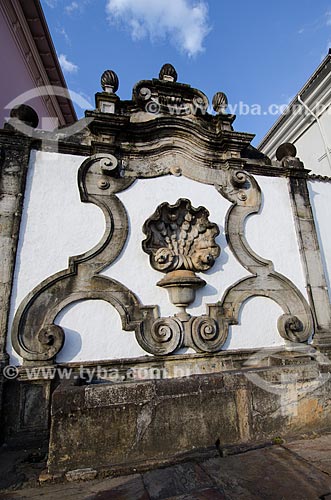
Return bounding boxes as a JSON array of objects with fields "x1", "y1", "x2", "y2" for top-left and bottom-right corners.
[{"x1": 12, "y1": 153, "x2": 313, "y2": 364}]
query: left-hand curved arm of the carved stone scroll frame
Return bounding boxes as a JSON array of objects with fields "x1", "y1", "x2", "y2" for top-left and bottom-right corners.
[{"x1": 12, "y1": 154, "x2": 161, "y2": 363}]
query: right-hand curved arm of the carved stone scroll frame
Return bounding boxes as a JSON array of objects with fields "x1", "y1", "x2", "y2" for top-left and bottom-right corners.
[{"x1": 216, "y1": 170, "x2": 314, "y2": 342}]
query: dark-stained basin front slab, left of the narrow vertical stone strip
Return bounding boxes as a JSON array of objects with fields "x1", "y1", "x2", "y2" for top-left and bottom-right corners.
[{"x1": 49, "y1": 376, "x2": 240, "y2": 473}]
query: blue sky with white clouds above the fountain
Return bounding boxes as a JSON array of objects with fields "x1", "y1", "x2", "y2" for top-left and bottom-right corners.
[{"x1": 41, "y1": 0, "x2": 331, "y2": 144}]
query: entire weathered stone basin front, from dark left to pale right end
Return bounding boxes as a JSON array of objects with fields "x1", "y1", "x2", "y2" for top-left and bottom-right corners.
[{"x1": 48, "y1": 358, "x2": 331, "y2": 473}]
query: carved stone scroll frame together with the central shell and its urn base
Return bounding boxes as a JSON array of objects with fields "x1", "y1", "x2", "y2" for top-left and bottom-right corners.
[{"x1": 12, "y1": 150, "x2": 313, "y2": 363}]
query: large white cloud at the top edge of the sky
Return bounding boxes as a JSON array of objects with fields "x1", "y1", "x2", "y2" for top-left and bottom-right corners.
[{"x1": 106, "y1": 0, "x2": 210, "y2": 56}]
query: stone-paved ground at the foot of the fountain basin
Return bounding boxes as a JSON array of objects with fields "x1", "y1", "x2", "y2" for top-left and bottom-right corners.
[{"x1": 0, "y1": 434, "x2": 331, "y2": 500}]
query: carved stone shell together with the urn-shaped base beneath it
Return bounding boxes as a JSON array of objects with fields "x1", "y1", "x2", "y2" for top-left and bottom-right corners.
[{"x1": 142, "y1": 198, "x2": 220, "y2": 319}]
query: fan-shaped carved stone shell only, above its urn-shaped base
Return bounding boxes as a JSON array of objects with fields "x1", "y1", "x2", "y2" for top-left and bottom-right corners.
[{"x1": 142, "y1": 198, "x2": 220, "y2": 273}]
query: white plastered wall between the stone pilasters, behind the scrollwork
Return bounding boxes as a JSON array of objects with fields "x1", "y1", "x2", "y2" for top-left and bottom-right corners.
[{"x1": 8, "y1": 152, "x2": 306, "y2": 363}]
